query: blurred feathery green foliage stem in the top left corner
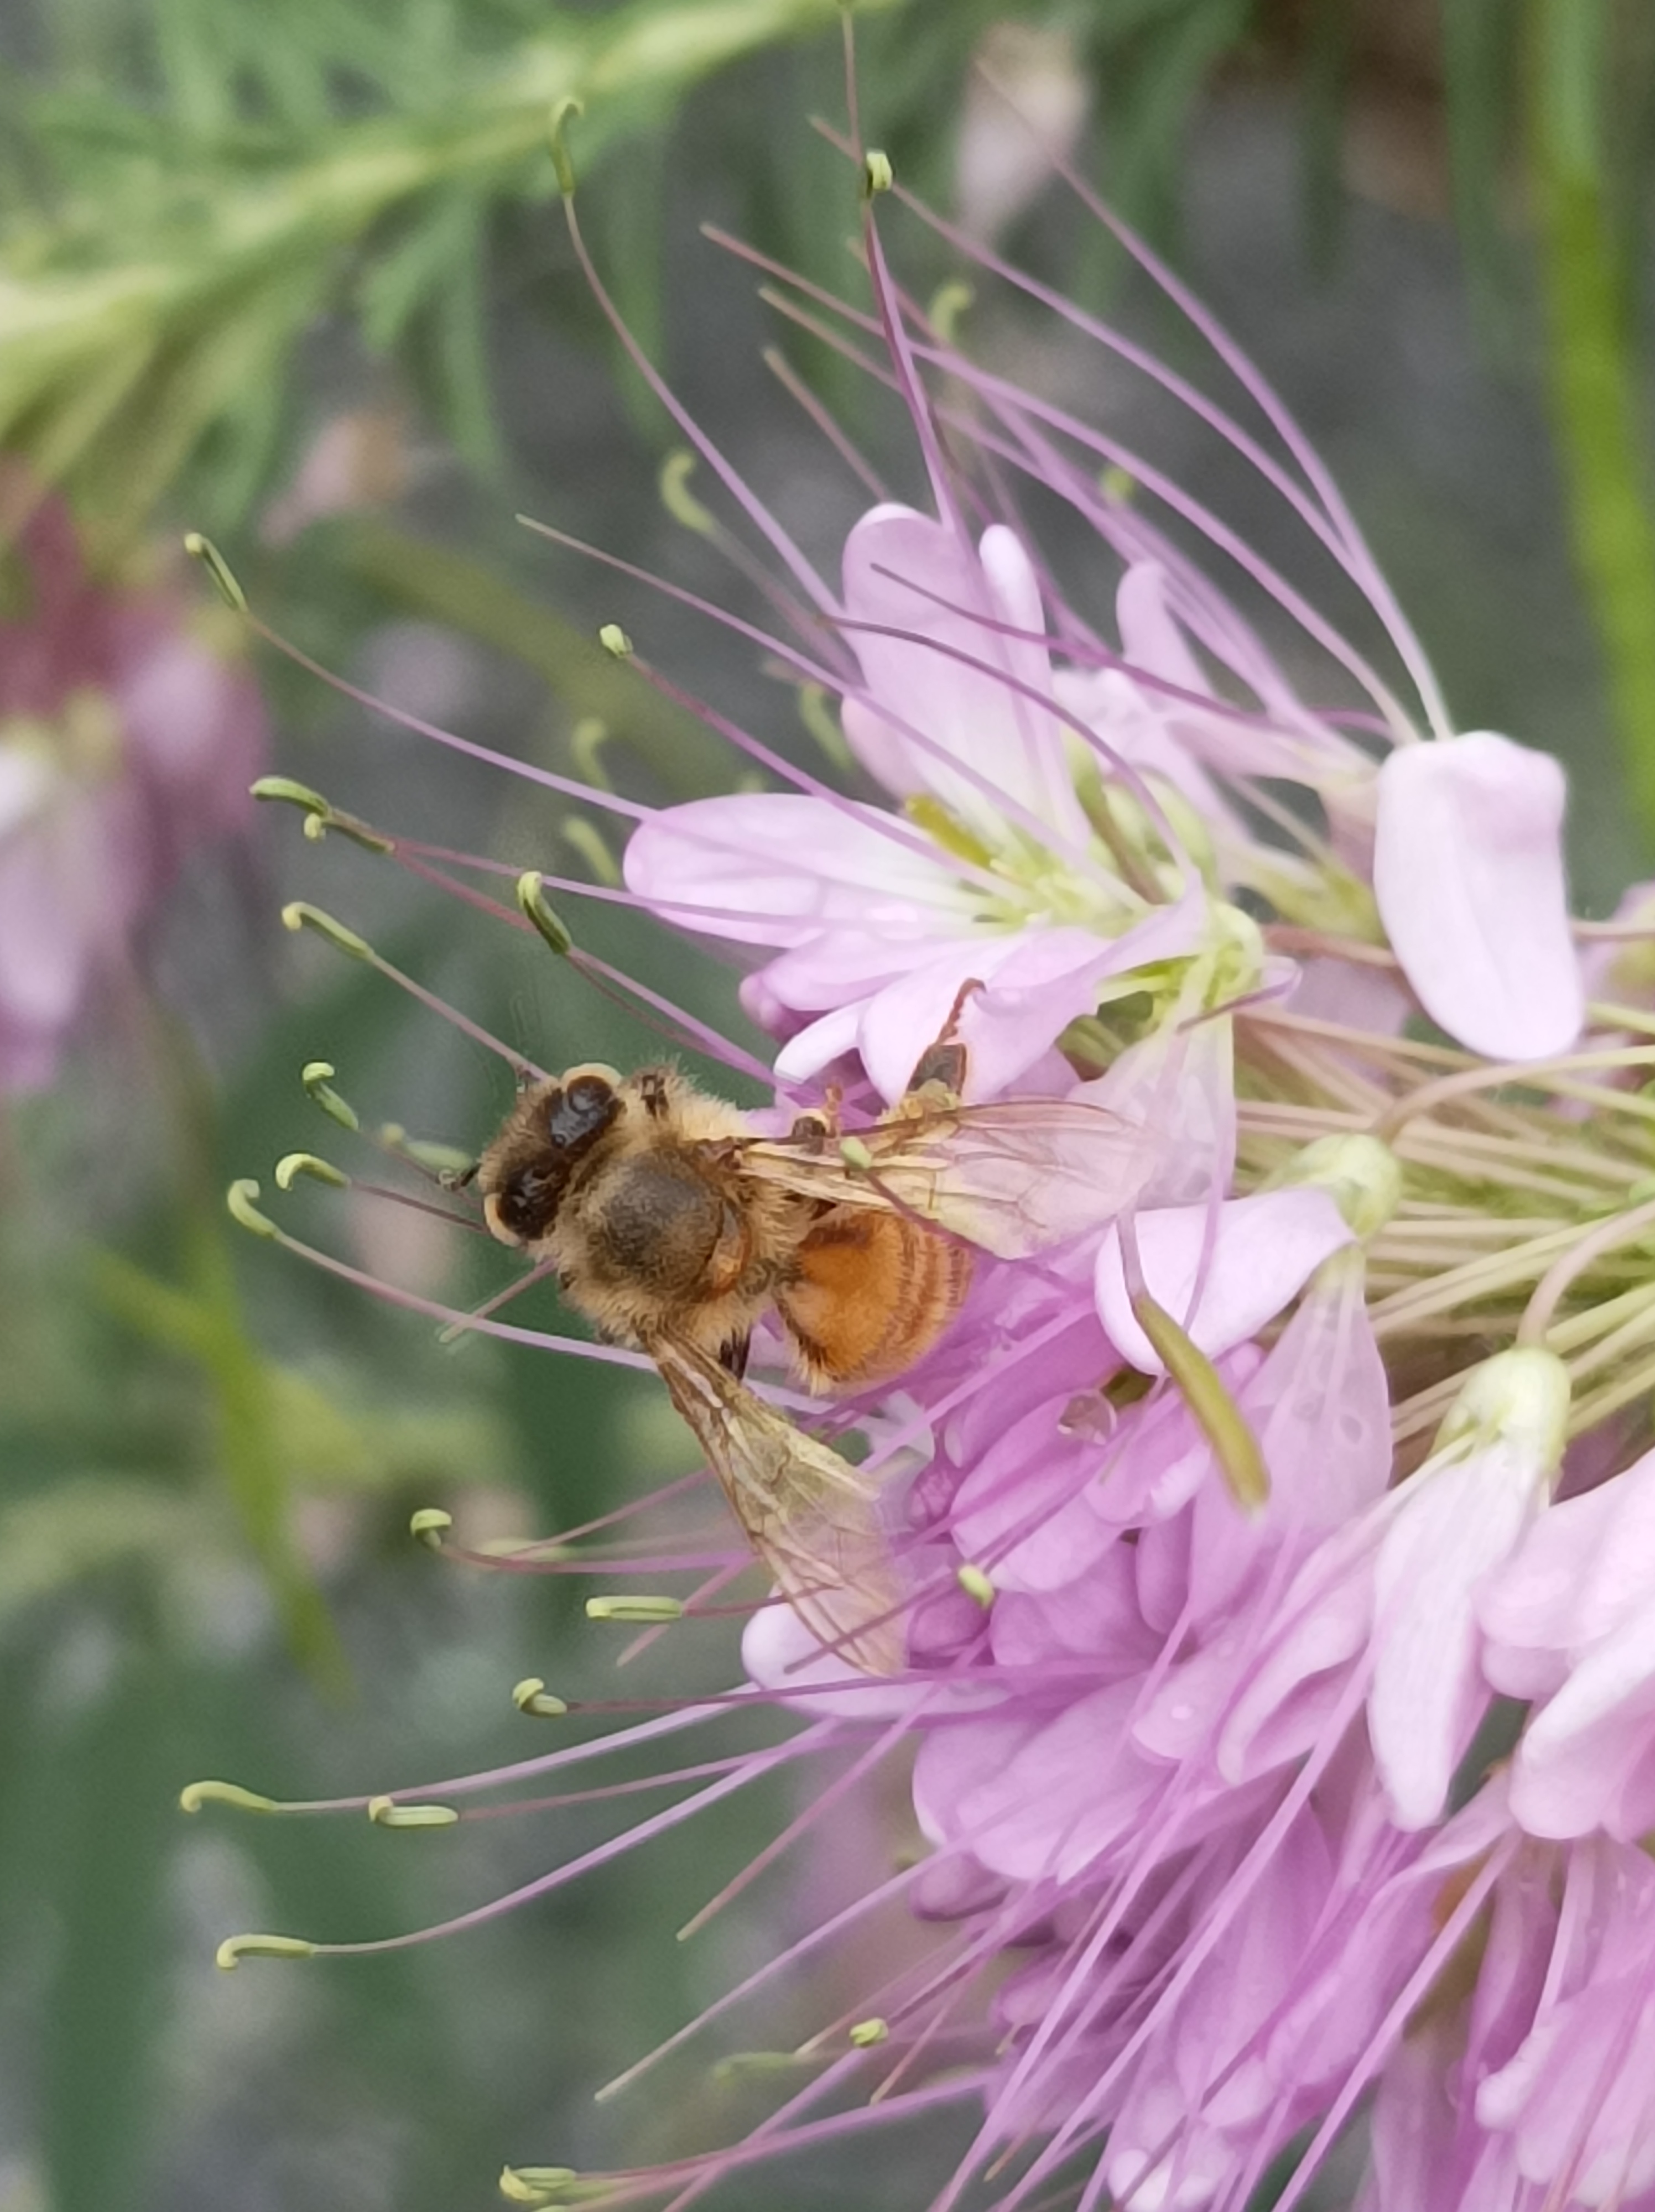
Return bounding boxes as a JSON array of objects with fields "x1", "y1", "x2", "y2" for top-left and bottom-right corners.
[{"x1": 0, "y1": 0, "x2": 907, "y2": 526}]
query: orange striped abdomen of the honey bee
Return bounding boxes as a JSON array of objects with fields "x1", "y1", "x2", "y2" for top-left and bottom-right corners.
[{"x1": 777, "y1": 1206, "x2": 971, "y2": 1389}]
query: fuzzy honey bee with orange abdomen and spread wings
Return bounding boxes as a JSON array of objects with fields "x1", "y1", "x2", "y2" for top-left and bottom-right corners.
[{"x1": 476, "y1": 1031, "x2": 1146, "y2": 1674}]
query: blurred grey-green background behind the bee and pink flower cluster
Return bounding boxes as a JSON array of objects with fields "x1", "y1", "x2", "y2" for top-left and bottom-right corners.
[{"x1": 0, "y1": 0, "x2": 1655, "y2": 2212}]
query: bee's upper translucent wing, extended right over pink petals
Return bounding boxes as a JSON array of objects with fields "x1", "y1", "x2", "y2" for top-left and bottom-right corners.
[{"x1": 739, "y1": 1099, "x2": 1155, "y2": 1259}]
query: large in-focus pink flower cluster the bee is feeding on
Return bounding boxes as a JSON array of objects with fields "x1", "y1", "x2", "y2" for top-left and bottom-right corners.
[{"x1": 210, "y1": 129, "x2": 1655, "y2": 2212}]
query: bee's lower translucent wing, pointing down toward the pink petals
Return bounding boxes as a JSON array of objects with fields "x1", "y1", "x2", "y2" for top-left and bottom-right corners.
[{"x1": 648, "y1": 1334, "x2": 907, "y2": 1674}]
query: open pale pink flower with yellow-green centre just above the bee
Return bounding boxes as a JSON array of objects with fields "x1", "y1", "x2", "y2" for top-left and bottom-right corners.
[{"x1": 626, "y1": 507, "x2": 1206, "y2": 1099}]
